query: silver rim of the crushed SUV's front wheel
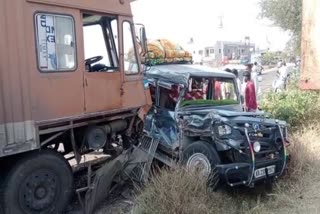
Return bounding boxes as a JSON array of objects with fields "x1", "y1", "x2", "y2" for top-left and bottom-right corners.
[{"x1": 187, "y1": 153, "x2": 211, "y2": 177}]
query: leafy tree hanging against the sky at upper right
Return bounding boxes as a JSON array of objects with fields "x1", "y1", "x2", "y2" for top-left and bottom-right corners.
[{"x1": 259, "y1": 0, "x2": 302, "y2": 51}]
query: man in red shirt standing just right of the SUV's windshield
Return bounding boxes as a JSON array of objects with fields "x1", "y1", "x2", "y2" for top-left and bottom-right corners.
[{"x1": 244, "y1": 71, "x2": 257, "y2": 112}]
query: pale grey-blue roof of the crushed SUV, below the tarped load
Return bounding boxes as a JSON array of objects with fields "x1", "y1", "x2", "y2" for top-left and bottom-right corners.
[{"x1": 146, "y1": 64, "x2": 235, "y2": 85}]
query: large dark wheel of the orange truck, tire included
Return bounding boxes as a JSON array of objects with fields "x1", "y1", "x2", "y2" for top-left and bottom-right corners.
[{"x1": 2, "y1": 150, "x2": 73, "y2": 214}]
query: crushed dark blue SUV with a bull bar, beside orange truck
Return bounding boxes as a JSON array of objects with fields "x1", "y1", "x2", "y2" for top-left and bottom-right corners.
[{"x1": 145, "y1": 65, "x2": 289, "y2": 188}]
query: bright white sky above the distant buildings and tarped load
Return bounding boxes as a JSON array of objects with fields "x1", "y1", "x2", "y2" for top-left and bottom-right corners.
[{"x1": 131, "y1": 0, "x2": 289, "y2": 50}]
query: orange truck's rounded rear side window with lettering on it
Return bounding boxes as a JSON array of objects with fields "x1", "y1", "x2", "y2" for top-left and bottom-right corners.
[{"x1": 35, "y1": 13, "x2": 76, "y2": 72}]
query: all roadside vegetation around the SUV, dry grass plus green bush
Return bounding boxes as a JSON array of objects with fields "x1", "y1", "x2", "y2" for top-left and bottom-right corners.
[{"x1": 133, "y1": 77, "x2": 320, "y2": 214}]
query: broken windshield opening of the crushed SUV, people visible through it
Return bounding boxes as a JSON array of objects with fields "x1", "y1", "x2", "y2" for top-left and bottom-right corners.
[{"x1": 181, "y1": 77, "x2": 240, "y2": 106}]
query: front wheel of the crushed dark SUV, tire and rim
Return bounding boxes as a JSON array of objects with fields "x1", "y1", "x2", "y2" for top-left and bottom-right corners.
[{"x1": 182, "y1": 141, "x2": 221, "y2": 189}]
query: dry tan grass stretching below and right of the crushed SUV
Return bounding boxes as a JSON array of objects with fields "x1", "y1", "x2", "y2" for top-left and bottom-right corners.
[{"x1": 133, "y1": 124, "x2": 320, "y2": 214}]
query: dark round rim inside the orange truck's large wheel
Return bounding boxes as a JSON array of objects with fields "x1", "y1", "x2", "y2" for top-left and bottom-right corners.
[{"x1": 19, "y1": 170, "x2": 59, "y2": 212}]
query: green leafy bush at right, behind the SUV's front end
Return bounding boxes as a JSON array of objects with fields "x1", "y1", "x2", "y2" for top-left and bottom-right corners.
[{"x1": 261, "y1": 86, "x2": 320, "y2": 128}]
